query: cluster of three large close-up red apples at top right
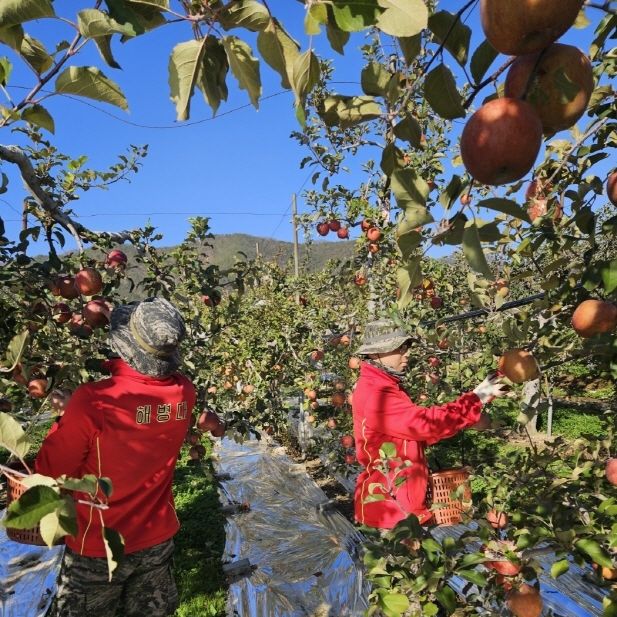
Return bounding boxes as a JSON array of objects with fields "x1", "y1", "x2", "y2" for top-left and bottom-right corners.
[{"x1": 461, "y1": 0, "x2": 594, "y2": 186}]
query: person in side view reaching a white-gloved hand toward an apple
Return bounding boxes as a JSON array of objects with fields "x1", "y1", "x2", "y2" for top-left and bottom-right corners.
[{"x1": 352, "y1": 319, "x2": 507, "y2": 529}]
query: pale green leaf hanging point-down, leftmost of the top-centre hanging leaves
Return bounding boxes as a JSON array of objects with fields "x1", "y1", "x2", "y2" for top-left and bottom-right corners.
[{"x1": 169, "y1": 38, "x2": 207, "y2": 120}]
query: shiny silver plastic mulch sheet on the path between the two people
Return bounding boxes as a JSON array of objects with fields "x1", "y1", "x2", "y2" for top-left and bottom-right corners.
[{"x1": 214, "y1": 439, "x2": 369, "y2": 617}]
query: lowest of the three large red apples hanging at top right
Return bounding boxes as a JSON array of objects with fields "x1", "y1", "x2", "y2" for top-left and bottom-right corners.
[{"x1": 461, "y1": 98, "x2": 542, "y2": 185}]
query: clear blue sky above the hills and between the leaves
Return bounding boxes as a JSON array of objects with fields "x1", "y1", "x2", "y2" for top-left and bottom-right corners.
[{"x1": 0, "y1": 0, "x2": 601, "y2": 253}]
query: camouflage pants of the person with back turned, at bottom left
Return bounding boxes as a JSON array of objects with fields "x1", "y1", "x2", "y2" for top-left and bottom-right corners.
[{"x1": 49, "y1": 540, "x2": 178, "y2": 617}]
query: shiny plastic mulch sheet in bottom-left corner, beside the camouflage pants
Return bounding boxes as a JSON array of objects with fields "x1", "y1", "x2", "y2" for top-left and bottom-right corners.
[{"x1": 0, "y1": 510, "x2": 64, "y2": 617}]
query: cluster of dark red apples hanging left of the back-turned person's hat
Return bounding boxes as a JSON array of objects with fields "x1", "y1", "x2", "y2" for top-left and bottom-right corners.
[{"x1": 50, "y1": 249, "x2": 127, "y2": 338}]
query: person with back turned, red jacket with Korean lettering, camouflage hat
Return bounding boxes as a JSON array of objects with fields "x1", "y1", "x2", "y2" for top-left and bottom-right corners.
[{"x1": 35, "y1": 298, "x2": 195, "y2": 617}]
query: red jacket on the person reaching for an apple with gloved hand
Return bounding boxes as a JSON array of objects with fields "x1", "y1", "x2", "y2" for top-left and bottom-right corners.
[{"x1": 352, "y1": 362, "x2": 482, "y2": 529}]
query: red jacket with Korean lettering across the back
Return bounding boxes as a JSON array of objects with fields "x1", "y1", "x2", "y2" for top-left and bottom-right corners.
[{"x1": 36, "y1": 360, "x2": 195, "y2": 557}]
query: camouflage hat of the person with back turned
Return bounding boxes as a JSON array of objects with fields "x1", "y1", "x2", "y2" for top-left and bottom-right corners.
[{"x1": 109, "y1": 298, "x2": 186, "y2": 377}]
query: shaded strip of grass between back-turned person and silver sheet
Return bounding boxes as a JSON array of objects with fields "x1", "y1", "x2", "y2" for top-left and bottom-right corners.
[{"x1": 174, "y1": 438, "x2": 227, "y2": 617}]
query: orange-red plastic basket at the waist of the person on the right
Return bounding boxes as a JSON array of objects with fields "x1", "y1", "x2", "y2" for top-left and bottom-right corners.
[{"x1": 426, "y1": 467, "x2": 471, "y2": 525}]
